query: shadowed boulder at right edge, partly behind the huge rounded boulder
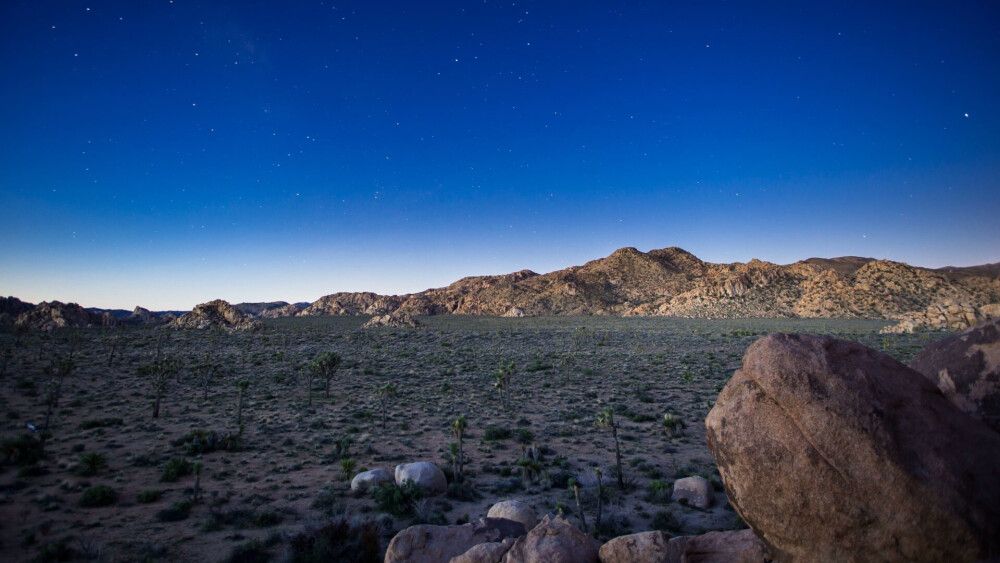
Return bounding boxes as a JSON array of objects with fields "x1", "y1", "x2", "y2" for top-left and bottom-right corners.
[{"x1": 910, "y1": 319, "x2": 1000, "y2": 432}]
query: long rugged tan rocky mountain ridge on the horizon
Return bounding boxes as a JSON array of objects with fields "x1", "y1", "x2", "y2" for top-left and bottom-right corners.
[{"x1": 299, "y1": 248, "x2": 1000, "y2": 324}]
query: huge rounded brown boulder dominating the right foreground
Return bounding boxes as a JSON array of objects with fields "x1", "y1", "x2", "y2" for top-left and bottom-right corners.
[{"x1": 705, "y1": 334, "x2": 1000, "y2": 561}]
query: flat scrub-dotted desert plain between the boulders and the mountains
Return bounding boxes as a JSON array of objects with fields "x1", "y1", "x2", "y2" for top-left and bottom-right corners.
[{"x1": 0, "y1": 316, "x2": 943, "y2": 561}]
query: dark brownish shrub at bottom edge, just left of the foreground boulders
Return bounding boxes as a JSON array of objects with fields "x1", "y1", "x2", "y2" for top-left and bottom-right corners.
[{"x1": 288, "y1": 516, "x2": 391, "y2": 563}]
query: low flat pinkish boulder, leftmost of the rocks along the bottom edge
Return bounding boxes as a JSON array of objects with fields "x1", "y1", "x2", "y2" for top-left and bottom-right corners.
[{"x1": 385, "y1": 518, "x2": 527, "y2": 563}]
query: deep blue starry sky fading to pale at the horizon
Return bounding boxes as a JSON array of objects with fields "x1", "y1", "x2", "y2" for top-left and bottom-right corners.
[{"x1": 0, "y1": 0, "x2": 1000, "y2": 309}]
